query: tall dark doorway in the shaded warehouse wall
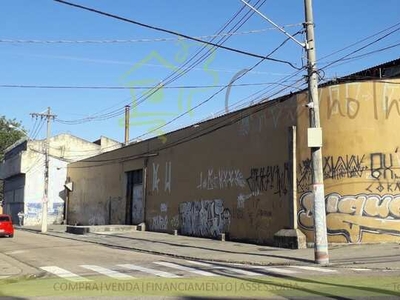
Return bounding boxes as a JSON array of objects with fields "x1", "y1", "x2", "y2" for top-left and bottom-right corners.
[{"x1": 126, "y1": 169, "x2": 144, "y2": 225}]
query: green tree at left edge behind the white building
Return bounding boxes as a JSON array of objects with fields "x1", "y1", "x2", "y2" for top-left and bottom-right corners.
[{"x1": 0, "y1": 116, "x2": 24, "y2": 202}]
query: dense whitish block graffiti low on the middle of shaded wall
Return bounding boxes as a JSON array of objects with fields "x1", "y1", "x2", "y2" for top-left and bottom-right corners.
[{"x1": 179, "y1": 199, "x2": 231, "y2": 237}]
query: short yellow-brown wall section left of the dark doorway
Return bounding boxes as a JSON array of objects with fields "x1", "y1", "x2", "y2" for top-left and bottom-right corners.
[{"x1": 68, "y1": 144, "x2": 147, "y2": 225}]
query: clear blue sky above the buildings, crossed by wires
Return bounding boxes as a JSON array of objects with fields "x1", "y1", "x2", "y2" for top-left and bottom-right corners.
[{"x1": 0, "y1": 0, "x2": 400, "y2": 142}]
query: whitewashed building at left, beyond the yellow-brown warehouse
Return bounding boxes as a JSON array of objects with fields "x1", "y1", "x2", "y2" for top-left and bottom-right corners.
[{"x1": 0, "y1": 134, "x2": 121, "y2": 225}]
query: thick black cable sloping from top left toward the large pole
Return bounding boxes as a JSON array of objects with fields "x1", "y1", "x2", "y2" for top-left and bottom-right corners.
[{"x1": 53, "y1": 0, "x2": 298, "y2": 69}]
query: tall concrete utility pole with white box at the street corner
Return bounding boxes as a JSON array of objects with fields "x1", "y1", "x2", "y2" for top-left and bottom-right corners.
[{"x1": 304, "y1": 0, "x2": 329, "y2": 265}]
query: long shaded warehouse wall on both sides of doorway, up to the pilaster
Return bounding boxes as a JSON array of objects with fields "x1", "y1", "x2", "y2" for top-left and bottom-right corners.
[{"x1": 68, "y1": 97, "x2": 296, "y2": 243}]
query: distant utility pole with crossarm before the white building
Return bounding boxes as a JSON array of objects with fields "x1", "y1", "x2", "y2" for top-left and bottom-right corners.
[{"x1": 30, "y1": 107, "x2": 56, "y2": 232}]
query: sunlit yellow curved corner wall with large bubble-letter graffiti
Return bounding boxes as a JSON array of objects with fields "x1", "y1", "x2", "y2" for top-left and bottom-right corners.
[{"x1": 298, "y1": 80, "x2": 400, "y2": 243}]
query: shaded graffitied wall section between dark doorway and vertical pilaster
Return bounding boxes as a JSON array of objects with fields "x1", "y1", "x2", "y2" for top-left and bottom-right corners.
[{"x1": 146, "y1": 98, "x2": 296, "y2": 243}]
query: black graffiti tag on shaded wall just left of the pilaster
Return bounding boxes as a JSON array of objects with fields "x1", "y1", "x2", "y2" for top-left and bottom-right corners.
[{"x1": 247, "y1": 163, "x2": 291, "y2": 196}]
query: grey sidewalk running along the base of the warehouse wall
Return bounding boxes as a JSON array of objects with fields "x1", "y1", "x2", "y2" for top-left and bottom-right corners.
[{"x1": 16, "y1": 225, "x2": 400, "y2": 270}]
